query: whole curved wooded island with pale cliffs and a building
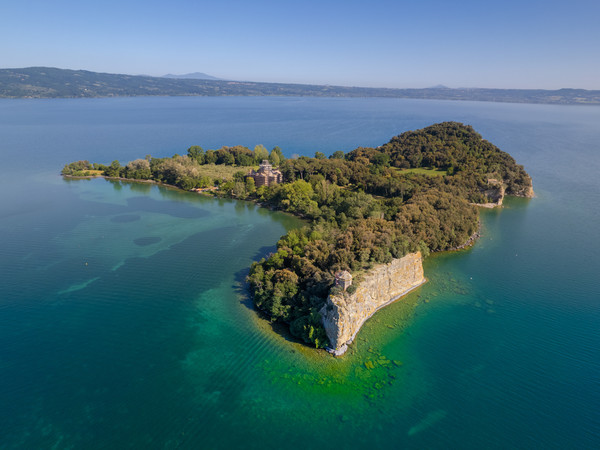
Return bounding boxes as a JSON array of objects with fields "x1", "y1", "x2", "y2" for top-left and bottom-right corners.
[{"x1": 62, "y1": 122, "x2": 533, "y2": 355}]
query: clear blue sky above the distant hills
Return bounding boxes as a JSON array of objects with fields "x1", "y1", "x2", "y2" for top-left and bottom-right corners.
[{"x1": 0, "y1": 0, "x2": 600, "y2": 89}]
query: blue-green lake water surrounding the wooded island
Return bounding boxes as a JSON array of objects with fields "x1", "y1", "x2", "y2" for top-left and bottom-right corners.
[{"x1": 0, "y1": 98, "x2": 600, "y2": 449}]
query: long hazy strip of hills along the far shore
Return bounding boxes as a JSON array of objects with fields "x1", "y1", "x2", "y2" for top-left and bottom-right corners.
[{"x1": 0, "y1": 67, "x2": 600, "y2": 104}]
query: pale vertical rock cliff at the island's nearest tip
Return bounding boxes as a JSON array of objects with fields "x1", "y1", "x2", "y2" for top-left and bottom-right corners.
[{"x1": 320, "y1": 252, "x2": 425, "y2": 355}]
